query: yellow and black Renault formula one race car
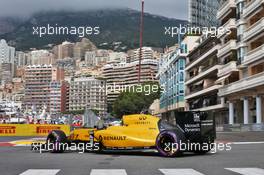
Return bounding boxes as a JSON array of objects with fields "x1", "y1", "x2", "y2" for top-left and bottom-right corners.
[{"x1": 40, "y1": 112, "x2": 216, "y2": 157}]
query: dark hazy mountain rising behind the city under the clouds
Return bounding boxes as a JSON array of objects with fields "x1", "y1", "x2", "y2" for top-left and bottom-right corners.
[{"x1": 0, "y1": 9, "x2": 187, "y2": 50}]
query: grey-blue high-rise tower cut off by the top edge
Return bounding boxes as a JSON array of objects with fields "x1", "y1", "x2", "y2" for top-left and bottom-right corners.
[{"x1": 189, "y1": 0, "x2": 222, "y2": 27}]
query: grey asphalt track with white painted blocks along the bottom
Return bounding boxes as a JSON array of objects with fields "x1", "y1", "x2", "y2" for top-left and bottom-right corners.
[{"x1": 0, "y1": 135, "x2": 264, "y2": 175}]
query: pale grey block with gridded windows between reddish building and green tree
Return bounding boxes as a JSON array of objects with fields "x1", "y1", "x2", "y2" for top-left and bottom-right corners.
[{"x1": 69, "y1": 77, "x2": 107, "y2": 116}]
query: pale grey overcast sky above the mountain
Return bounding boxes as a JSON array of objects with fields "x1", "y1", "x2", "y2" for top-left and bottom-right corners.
[{"x1": 0, "y1": 0, "x2": 188, "y2": 20}]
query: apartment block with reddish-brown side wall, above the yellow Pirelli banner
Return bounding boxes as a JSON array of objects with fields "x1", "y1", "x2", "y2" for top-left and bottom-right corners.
[{"x1": 23, "y1": 65, "x2": 67, "y2": 112}]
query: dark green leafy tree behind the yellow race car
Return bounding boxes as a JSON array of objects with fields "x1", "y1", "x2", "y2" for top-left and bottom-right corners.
[{"x1": 113, "y1": 82, "x2": 161, "y2": 118}]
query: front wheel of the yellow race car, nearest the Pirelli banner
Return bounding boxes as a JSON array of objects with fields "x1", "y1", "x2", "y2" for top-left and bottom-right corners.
[{"x1": 46, "y1": 130, "x2": 67, "y2": 153}]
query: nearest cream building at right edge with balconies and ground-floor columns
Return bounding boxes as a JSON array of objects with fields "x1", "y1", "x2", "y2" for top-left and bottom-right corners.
[{"x1": 217, "y1": 0, "x2": 264, "y2": 125}]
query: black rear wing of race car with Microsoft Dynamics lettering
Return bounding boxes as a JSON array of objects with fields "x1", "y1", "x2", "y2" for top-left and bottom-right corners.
[{"x1": 175, "y1": 111, "x2": 216, "y2": 142}]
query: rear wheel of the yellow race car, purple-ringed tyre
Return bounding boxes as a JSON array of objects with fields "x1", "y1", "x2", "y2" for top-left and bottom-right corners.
[{"x1": 156, "y1": 130, "x2": 181, "y2": 157}]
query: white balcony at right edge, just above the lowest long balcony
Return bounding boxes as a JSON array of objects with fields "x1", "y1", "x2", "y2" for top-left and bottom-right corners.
[{"x1": 242, "y1": 45, "x2": 264, "y2": 66}]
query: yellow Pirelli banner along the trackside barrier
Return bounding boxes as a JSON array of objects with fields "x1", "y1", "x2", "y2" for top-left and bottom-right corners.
[{"x1": 0, "y1": 124, "x2": 70, "y2": 136}]
